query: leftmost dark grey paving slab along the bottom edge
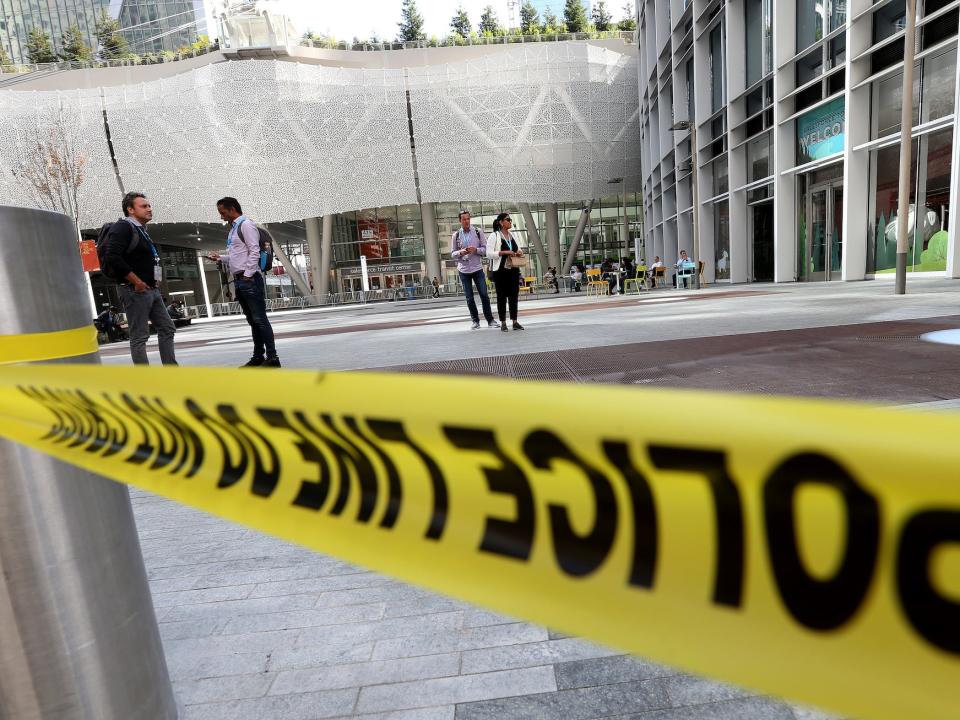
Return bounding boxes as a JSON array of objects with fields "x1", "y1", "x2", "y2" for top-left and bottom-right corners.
[{"x1": 457, "y1": 680, "x2": 670, "y2": 720}]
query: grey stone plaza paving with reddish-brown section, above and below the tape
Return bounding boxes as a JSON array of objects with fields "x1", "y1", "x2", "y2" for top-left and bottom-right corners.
[{"x1": 103, "y1": 279, "x2": 960, "y2": 720}]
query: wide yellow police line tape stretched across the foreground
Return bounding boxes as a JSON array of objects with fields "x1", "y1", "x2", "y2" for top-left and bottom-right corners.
[{"x1": 0, "y1": 366, "x2": 960, "y2": 720}]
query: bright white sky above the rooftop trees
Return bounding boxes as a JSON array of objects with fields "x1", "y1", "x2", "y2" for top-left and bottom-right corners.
[{"x1": 264, "y1": 0, "x2": 608, "y2": 40}]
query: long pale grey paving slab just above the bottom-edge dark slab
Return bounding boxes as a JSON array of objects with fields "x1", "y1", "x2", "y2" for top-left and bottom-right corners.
[{"x1": 357, "y1": 667, "x2": 557, "y2": 720}]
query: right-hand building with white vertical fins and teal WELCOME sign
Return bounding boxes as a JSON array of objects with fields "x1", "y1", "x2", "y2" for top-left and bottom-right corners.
[{"x1": 638, "y1": 0, "x2": 960, "y2": 282}]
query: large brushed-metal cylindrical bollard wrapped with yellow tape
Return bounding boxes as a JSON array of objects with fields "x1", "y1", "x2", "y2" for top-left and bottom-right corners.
[{"x1": 0, "y1": 207, "x2": 177, "y2": 720}]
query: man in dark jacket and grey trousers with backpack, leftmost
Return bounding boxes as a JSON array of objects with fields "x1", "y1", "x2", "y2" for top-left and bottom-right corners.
[{"x1": 104, "y1": 192, "x2": 177, "y2": 365}]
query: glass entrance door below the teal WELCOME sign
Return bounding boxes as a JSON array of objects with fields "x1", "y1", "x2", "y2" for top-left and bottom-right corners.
[{"x1": 800, "y1": 180, "x2": 843, "y2": 281}]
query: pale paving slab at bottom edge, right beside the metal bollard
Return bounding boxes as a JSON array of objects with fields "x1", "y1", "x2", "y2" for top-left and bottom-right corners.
[{"x1": 183, "y1": 690, "x2": 357, "y2": 720}]
